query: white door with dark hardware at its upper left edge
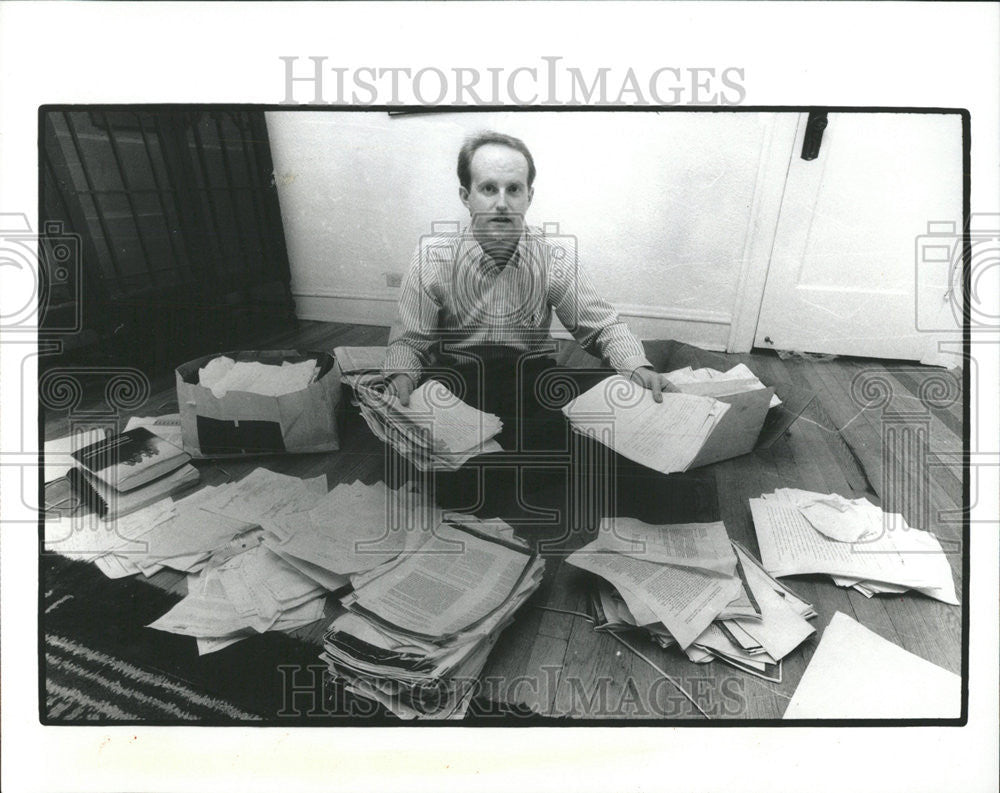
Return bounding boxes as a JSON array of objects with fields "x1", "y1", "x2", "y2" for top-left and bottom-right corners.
[{"x1": 754, "y1": 113, "x2": 962, "y2": 361}]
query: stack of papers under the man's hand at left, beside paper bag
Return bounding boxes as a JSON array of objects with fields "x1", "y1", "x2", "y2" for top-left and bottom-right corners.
[{"x1": 357, "y1": 380, "x2": 503, "y2": 471}]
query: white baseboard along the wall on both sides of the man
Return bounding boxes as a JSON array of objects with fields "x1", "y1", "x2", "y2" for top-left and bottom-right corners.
[{"x1": 294, "y1": 290, "x2": 732, "y2": 350}]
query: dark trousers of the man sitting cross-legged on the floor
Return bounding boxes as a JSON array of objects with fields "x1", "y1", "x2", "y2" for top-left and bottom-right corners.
[{"x1": 429, "y1": 352, "x2": 718, "y2": 535}]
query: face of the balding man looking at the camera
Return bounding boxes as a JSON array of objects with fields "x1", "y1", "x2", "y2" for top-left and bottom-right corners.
[{"x1": 458, "y1": 143, "x2": 534, "y2": 242}]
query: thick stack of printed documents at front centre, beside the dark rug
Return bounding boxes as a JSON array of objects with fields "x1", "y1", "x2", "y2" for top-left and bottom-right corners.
[{"x1": 322, "y1": 514, "x2": 543, "y2": 719}]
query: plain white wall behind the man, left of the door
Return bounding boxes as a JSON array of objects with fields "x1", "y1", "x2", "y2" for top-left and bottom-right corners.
[{"x1": 267, "y1": 111, "x2": 787, "y2": 349}]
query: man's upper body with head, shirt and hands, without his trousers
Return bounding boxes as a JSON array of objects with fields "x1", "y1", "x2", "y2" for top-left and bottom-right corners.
[{"x1": 385, "y1": 132, "x2": 673, "y2": 405}]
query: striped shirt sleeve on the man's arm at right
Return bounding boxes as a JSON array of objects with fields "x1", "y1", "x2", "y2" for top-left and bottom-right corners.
[{"x1": 549, "y1": 241, "x2": 652, "y2": 377}]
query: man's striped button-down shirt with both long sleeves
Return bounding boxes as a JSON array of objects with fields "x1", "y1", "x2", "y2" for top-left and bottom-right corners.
[{"x1": 385, "y1": 227, "x2": 650, "y2": 383}]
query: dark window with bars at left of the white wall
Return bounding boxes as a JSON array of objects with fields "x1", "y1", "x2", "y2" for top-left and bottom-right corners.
[{"x1": 40, "y1": 108, "x2": 295, "y2": 369}]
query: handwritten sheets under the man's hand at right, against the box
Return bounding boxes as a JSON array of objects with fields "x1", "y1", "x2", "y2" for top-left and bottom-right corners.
[{"x1": 562, "y1": 375, "x2": 736, "y2": 474}]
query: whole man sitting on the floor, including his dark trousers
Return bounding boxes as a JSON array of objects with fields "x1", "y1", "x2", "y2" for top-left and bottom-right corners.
[{"x1": 384, "y1": 132, "x2": 674, "y2": 510}]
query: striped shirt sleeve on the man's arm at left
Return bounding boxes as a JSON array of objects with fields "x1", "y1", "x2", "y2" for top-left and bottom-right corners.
[{"x1": 382, "y1": 247, "x2": 441, "y2": 386}]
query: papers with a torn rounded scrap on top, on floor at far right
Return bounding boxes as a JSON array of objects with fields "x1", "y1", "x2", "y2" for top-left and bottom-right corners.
[{"x1": 750, "y1": 488, "x2": 958, "y2": 605}]
